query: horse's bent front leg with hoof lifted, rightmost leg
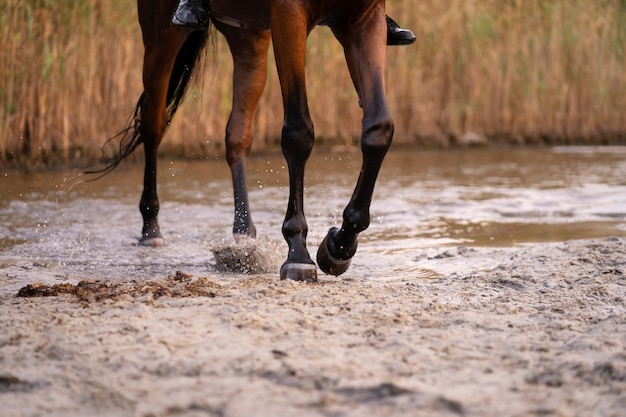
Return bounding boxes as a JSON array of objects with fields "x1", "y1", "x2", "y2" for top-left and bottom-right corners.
[{"x1": 317, "y1": 6, "x2": 393, "y2": 275}]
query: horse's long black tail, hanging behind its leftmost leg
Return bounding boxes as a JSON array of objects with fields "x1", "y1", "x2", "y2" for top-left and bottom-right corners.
[{"x1": 86, "y1": 30, "x2": 211, "y2": 178}]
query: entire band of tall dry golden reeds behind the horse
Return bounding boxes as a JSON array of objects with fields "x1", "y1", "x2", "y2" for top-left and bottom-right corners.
[{"x1": 0, "y1": 0, "x2": 626, "y2": 166}]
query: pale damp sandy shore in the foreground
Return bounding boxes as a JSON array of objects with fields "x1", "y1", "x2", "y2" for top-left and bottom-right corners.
[{"x1": 0, "y1": 238, "x2": 626, "y2": 417}]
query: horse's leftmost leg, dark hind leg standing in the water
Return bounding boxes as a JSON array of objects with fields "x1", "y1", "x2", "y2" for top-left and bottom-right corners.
[{"x1": 139, "y1": 5, "x2": 189, "y2": 246}]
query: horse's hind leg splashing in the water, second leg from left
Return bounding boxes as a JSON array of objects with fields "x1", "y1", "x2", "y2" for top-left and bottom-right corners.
[{"x1": 215, "y1": 22, "x2": 270, "y2": 241}]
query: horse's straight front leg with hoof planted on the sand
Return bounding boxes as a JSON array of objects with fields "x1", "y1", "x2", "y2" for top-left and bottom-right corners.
[{"x1": 271, "y1": 0, "x2": 317, "y2": 282}]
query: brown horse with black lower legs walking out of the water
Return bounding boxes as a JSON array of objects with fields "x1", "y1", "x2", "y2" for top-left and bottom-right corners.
[{"x1": 104, "y1": 0, "x2": 393, "y2": 282}]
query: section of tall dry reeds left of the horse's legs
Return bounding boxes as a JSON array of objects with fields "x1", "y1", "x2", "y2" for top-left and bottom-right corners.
[{"x1": 0, "y1": 0, "x2": 142, "y2": 164}]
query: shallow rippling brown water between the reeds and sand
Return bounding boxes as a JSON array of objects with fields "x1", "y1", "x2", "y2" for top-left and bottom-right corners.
[{"x1": 0, "y1": 147, "x2": 626, "y2": 281}]
